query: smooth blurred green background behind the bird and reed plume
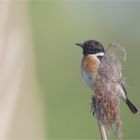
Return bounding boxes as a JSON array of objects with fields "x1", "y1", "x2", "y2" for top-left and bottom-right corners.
[{"x1": 29, "y1": 0, "x2": 140, "y2": 139}]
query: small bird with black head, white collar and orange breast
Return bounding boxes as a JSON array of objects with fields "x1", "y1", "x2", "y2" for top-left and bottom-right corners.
[{"x1": 75, "y1": 40, "x2": 138, "y2": 114}]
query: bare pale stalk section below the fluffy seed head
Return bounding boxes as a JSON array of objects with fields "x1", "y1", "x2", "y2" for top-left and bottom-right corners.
[{"x1": 97, "y1": 120, "x2": 107, "y2": 140}]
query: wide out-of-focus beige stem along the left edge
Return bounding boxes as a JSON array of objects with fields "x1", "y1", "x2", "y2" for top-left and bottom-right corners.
[{"x1": 0, "y1": 0, "x2": 45, "y2": 140}]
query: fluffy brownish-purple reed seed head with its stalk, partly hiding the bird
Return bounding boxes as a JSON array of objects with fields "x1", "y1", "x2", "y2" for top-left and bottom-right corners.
[{"x1": 92, "y1": 45, "x2": 124, "y2": 140}]
